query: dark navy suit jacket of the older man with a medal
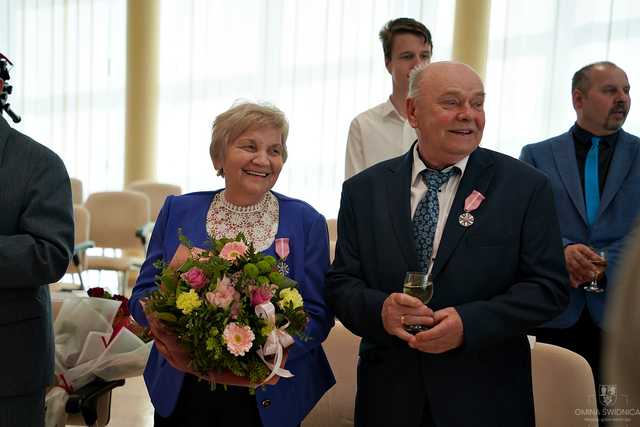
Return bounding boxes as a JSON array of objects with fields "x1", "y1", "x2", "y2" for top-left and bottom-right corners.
[{"x1": 327, "y1": 148, "x2": 568, "y2": 427}]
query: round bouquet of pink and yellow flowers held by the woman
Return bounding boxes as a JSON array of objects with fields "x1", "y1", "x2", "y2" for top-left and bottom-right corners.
[{"x1": 145, "y1": 234, "x2": 308, "y2": 385}]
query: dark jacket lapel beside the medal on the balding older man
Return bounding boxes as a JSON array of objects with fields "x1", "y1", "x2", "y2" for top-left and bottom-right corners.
[{"x1": 432, "y1": 148, "x2": 494, "y2": 277}]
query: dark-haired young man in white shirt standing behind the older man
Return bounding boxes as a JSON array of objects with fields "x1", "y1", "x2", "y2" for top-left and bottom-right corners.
[{"x1": 345, "y1": 18, "x2": 433, "y2": 179}]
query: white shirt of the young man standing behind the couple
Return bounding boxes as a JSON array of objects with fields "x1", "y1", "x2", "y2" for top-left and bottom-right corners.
[{"x1": 345, "y1": 100, "x2": 417, "y2": 179}]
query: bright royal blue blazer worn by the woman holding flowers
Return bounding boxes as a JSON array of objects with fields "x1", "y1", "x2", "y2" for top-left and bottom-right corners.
[{"x1": 129, "y1": 192, "x2": 335, "y2": 427}]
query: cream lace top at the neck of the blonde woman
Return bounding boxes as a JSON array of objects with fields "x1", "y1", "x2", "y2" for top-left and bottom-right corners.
[{"x1": 207, "y1": 190, "x2": 280, "y2": 252}]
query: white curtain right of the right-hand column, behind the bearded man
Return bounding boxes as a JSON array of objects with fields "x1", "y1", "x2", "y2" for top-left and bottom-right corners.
[{"x1": 483, "y1": 0, "x2": 640, "y2": 157}]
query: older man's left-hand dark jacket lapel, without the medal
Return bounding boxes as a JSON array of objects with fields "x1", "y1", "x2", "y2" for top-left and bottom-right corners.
[{"x1": 386, "y1": 144, "x2": 418, "y2": 270}]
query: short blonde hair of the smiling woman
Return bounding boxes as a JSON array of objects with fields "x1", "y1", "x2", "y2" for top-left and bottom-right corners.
[{"x1": 209, "y1": 101, "x2": 289, "y2": 176}]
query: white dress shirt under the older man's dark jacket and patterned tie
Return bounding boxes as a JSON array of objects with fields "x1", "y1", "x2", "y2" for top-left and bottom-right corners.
[{"x1": 411, "y1": 144, "x2": 469, "y2": 271}]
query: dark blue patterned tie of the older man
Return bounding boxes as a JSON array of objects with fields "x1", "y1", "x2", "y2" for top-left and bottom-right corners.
[{"x1": 413, "y1": 167, "x2": 459, "y2": 273}]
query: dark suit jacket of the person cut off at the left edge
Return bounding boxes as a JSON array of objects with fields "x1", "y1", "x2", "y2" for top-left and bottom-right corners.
[{"x1": 0, "y1": 117, "x2": 73, "y2": 397}]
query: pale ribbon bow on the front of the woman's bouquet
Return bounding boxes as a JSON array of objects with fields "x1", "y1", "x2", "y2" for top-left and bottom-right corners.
[{"x1": 255, "y1": 302, "x2": 294, "y2": 383}]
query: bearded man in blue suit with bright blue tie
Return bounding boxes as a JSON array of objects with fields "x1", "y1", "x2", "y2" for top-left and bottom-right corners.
[{"x1": 520, "y1": 62, "x2": 640, "y2": 402}]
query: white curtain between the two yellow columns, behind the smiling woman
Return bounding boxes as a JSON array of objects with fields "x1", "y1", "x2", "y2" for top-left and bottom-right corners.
[{"x1": 158, "y1": 0, "x2": 455, "y2": 217}]
